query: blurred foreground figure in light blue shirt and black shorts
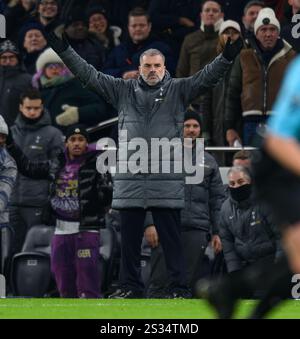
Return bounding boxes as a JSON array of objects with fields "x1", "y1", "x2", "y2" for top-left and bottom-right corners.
[{"x1": 197, "y1": 57, "x2": 300, "y2": 318}]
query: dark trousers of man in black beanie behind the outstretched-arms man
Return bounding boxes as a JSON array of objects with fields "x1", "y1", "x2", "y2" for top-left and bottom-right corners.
[{"x1": 147, "y1": 229, "x2": 208, "y2": 297}]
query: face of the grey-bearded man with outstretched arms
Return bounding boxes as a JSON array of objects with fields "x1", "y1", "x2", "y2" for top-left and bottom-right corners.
[{"x1": 139, "y1": 55, "x2": 166, "y2": 86}]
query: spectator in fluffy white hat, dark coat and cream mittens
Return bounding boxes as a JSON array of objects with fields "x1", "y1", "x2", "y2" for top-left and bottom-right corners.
[{"x1": 33, "y1": 48, "x2": 113, "y2": 131}]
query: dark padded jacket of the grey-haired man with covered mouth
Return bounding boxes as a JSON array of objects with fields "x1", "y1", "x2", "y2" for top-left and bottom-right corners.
[{"x1": 219, "y1": 197, "x2": 281, "y2": 272}]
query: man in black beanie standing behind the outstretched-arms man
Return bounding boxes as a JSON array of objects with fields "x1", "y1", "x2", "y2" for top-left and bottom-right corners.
[{"x1": 145, "y1": 111, "x2": 226, "y2": 298}]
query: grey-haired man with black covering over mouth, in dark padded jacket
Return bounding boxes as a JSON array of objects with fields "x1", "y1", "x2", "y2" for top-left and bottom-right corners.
[{"x1": 219, "y1": 166, "x2": 281, "y2": 273}]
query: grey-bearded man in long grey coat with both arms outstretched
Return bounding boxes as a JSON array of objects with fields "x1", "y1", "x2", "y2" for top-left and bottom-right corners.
[{"x1": 48, "y1": 33, "x2": 242, "y2": 298}]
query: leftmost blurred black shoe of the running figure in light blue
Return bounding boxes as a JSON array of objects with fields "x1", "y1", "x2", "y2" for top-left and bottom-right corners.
[{"x1": 196, "y1": 279, "x2": 237, "y2": 319}]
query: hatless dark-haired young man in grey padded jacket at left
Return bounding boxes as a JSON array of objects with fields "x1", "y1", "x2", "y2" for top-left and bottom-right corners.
[{"x1": 10, "y1": 88, "x2": 63, "y2": 253}]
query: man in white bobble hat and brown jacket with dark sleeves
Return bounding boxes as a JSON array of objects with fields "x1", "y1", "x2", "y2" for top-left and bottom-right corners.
[{"x1": 224, "y1": 7, "x2": 295, "y2": 146}]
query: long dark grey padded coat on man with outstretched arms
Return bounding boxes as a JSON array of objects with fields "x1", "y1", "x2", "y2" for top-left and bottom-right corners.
[{"x1": 60, "y1": 47, "x2": 230, "y2": 209}]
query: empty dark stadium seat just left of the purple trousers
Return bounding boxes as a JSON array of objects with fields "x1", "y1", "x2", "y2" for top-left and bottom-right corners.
[{"x1": 10, "y1": 225, "x2": 55, "y2": 297}]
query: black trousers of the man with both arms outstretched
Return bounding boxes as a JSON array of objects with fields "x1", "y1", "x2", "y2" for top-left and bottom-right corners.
[{"x1": 120, "y1": 208, "x2": 186, "y2": 291}]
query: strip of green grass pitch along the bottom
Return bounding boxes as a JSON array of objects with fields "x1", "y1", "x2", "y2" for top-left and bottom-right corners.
[{"x1": 0, "y1": 298, "x2": 300, "y2": 319}]
